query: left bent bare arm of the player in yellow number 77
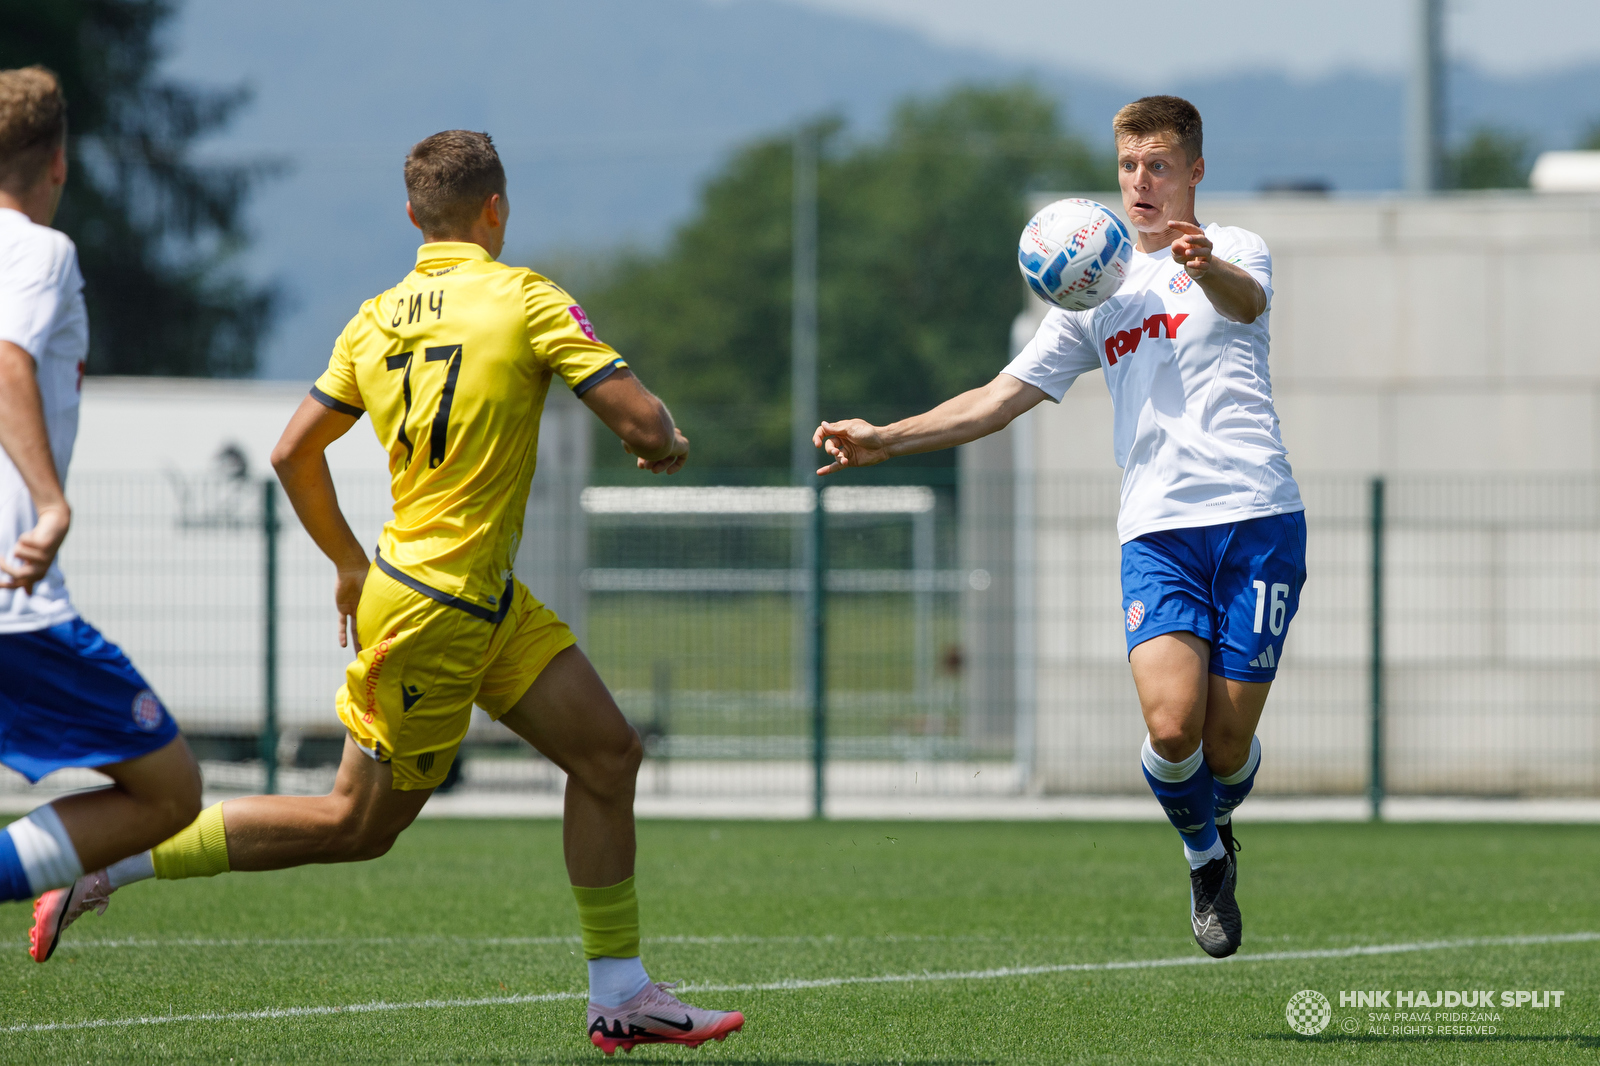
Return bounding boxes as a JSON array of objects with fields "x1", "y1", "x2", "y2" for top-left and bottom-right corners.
[{"x1": 272, "y1": 397, "x2": 368, "y2": 651}]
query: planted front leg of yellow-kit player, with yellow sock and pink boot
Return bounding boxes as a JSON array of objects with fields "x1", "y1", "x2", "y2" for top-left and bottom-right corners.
[{"x1": 499, "y1": 647, "x2": 744, "y2": 1055}]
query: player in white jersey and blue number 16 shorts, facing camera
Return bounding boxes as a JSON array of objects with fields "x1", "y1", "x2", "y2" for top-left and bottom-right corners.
[{"x1": 814, "y1": 96, "x2": 1306, "y2": 959}]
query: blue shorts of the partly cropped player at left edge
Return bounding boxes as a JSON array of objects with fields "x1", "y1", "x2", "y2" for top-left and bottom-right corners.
[{"x1": 0, "y1": 618, "x2": 178, "y2": 781}]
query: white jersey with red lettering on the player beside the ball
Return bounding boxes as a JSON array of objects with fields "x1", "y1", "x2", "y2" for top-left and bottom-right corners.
[{"x1": 1005, "y1": 224, "x2": 1306, "y2": 544}]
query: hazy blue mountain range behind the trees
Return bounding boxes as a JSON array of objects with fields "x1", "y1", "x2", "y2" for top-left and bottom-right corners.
[{"x1": 159, "y1": 0, "x2": 1600, "y2": 379}]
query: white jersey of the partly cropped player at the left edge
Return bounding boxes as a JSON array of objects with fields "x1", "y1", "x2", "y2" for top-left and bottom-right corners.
[{"x1": 0, "y1": 208, "x2": 90, "y2": 634}]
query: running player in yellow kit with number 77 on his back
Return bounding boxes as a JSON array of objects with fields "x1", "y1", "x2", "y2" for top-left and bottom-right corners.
[{"x1": 29, "y1": 130, "x2": 744, "y2": 1055}]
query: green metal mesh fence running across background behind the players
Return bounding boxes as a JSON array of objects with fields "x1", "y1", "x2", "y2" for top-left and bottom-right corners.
[{"x1": 8, "y1": 474, "x2": 1600, "y2": 797}]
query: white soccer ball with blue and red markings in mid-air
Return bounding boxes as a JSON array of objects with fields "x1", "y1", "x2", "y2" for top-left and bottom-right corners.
[{"x1": 1016, "y1": 200, "x2": 1133, "y2": 311}]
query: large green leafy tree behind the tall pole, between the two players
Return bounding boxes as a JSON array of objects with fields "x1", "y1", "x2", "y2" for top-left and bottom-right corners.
[{"x1": 579, "y1": 85, "x2": 1115, "y2": 477}]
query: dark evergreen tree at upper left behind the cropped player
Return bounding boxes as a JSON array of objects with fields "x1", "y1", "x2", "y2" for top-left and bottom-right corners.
[{"x1": 0, "y1": 0, "x2": 277, "y2": 376}]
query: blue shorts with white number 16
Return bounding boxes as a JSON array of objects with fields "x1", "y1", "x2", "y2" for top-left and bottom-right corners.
[{"x1": 1122, "y1": 511, "x2": 1306, "y2": 682}]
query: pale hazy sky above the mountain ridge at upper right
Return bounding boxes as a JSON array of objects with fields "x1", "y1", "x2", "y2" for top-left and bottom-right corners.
[{"x1": 780, "y1": 0, "x2": 1600, "y2": 78}]
